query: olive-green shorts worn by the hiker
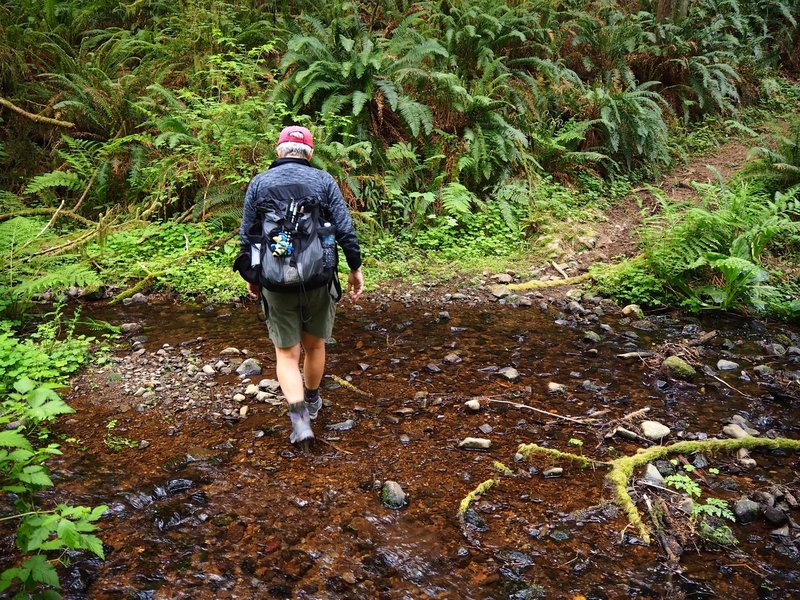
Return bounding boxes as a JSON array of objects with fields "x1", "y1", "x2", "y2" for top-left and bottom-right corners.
[{"x1": 261, "y1": 285, "x2": 336, "y2": 348}]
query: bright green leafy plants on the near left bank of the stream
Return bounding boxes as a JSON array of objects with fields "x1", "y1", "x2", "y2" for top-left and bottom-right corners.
[{"x1": 0, "y1": 307, "x2": 107, "y2": 598}]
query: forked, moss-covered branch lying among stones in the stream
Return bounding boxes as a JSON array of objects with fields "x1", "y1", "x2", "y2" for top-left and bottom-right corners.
[{"x1": 518, "y1": 437, "x2": 800, "y2": 544}]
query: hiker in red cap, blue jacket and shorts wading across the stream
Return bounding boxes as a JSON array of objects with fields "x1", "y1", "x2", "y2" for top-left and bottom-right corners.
[{"x1": 240, "y1": 126, "x2": 364, "y2": 444}]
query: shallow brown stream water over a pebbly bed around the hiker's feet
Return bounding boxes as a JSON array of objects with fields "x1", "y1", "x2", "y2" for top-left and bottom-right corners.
[{"x1": 12, "y1": 302, "x2": 800, "y2": 600}]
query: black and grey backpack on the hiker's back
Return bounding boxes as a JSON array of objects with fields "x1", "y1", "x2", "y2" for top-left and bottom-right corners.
[{"x1": 253, "y1": 184, "x2": 338, "y2": 292}]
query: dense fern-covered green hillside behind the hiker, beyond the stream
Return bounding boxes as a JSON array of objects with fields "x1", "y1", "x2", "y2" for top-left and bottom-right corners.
[{"x1": 0, "y1": 0, "x2": 800, "y2": 309}]
